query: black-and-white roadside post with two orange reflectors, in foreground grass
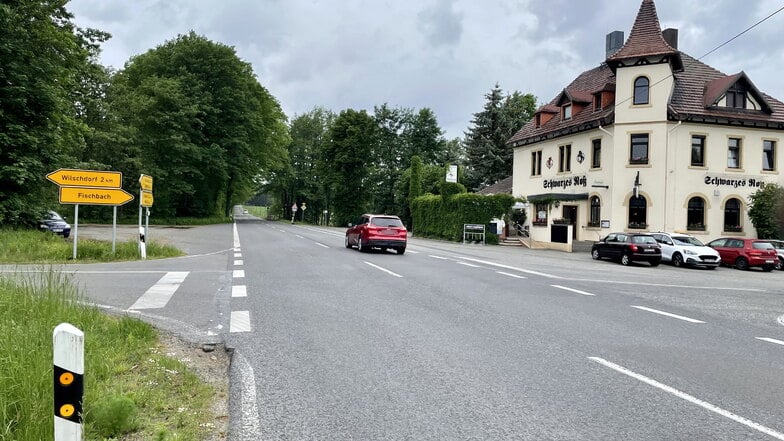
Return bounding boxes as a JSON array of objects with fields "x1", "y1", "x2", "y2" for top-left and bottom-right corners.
[{"x1": 52, "y1": 323, "x2": 84, "y2": 441}]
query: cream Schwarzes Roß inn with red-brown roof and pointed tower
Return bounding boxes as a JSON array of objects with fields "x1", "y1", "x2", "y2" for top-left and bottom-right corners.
[{"x1": 508, "y1": 0, "x2": 784, "y2": 242}]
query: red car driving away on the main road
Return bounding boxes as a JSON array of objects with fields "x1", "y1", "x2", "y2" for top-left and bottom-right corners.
[{"x1": 345, "y1": 214, "x2": 408, "y2": 254}]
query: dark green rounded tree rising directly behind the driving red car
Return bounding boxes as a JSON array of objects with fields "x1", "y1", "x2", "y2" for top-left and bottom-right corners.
[{"x1": 320, "y1": 109, "x2": 377, "y2": 225}]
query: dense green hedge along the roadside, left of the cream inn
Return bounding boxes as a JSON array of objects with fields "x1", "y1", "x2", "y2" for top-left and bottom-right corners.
[{"x1": 411, "y1": 192, "x2": 515, "y2": 241}]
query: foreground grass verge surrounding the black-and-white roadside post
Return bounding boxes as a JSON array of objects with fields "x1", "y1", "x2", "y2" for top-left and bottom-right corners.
[{"x1": 0, "y1": 271, "x2": 215, "y2": 441}]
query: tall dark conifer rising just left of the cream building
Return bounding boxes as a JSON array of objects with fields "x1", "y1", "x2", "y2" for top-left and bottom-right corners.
[{"x1": 465, "y1": 84, "x2": 536, "y2": 190}]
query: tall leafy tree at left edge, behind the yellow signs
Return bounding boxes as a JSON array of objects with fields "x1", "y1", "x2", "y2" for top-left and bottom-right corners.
[{"x1": 0, "y1": 0, "x2": 105, "y2": 225}]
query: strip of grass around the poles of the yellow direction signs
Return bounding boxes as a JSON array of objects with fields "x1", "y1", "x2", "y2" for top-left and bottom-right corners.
[{"x1": 0, "y1": 230, "x2": 183, "y2": 264}]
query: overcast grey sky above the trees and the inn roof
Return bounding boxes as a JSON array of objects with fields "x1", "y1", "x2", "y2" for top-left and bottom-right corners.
[{"x1": 67, "y1": 0, "x2": 784, "y2": 138}]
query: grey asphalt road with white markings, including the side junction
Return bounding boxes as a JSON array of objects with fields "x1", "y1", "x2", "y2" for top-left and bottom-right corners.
[{"x1": 12, "y1": 215, "x2": 784, "y2": 440}]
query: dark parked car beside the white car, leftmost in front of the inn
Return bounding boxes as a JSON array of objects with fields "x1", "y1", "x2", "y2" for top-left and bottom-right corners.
[{"x1": 591, "y1": 233, "x2": 661, "y2": 266}]
